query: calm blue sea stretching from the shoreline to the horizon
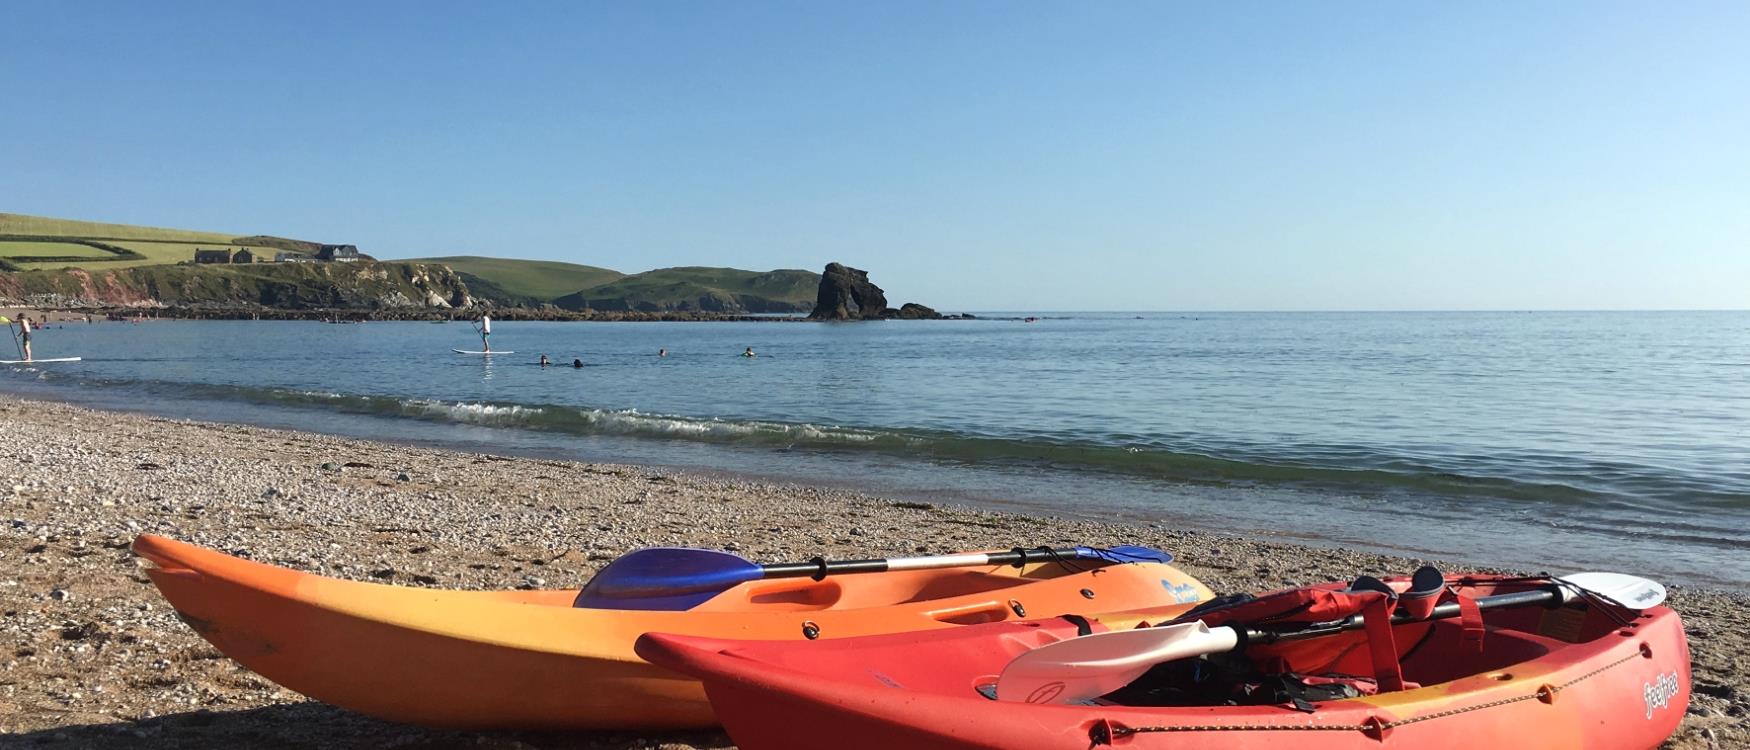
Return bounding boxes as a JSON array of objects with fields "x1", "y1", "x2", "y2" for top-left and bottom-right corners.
[{"x1": 0, "y1": 313, "x2": 1750, "y2": 587}]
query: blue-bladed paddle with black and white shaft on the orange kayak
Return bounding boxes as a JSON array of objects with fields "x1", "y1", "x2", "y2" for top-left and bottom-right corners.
[{"x1": 572, "y1": 545, "x2": 1173, "y2": 610}]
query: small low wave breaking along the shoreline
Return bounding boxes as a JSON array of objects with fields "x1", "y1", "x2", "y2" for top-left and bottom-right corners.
[{"x1": 204, "y1": 382, "x2": 1750, "y2": 510}]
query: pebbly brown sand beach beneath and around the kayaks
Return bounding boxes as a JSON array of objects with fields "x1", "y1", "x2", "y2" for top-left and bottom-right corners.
[{"x1": 0, "y1": 397, "x2": 1750, "y2": 748}]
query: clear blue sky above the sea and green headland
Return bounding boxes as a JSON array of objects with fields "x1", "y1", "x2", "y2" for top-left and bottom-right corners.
[{"x1": 0, "y1": 0, "x2": 1750, "y2": 309}]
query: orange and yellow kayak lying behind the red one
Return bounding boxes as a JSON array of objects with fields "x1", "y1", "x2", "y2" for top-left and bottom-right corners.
[{"x1": 133, "y1": 535, "x2": 1213, "y2": 729}]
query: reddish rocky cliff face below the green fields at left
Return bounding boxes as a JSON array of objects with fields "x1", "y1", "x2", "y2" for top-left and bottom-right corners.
[{"x1": 0, "y1": 262, "x2": 474, "y2": 309}]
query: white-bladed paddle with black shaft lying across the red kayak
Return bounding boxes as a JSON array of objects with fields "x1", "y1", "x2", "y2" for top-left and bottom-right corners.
[{"x1": 996, "y1": 573, "x2": 1664, "y2": 703}]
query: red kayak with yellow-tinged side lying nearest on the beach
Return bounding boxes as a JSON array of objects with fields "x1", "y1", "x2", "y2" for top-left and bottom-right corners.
[{"x1": 637, "y1": 568, "x2": 1691, "y2": 750}]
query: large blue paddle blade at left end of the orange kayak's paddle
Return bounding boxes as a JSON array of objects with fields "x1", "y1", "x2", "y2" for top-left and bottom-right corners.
[{"x1": 572, "y1": 547, "x2": 765, "y2": 612}]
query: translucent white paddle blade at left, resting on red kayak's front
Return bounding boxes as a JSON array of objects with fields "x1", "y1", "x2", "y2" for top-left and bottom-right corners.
[{"x1": 996, "y1": 622, "x2": 1239, "y2": 703}]
